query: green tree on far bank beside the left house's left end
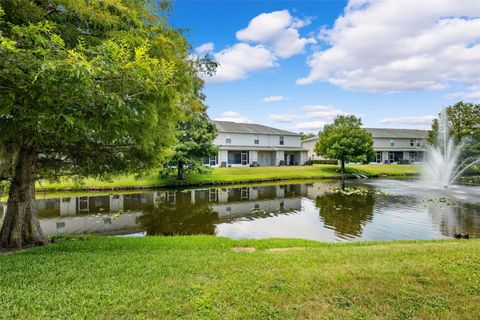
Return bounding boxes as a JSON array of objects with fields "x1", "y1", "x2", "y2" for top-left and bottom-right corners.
[{"x1": 164, "y1": 105, "x2": 218, "y2": 180}]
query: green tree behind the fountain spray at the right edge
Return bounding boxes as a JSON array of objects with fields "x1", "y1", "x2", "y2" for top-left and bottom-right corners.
[{"x1": 429, "y1": 102, "x2": 480, "y2": 159}]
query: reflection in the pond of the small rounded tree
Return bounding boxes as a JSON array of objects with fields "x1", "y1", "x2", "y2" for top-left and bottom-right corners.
[{"x1": 316, "y1": 189, "x2": 375, "y2": 238}]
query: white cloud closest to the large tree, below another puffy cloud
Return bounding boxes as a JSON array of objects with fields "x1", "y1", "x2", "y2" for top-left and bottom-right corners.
[{"x1": 205, "y1": 43, "x2": 276, "y2": 82}]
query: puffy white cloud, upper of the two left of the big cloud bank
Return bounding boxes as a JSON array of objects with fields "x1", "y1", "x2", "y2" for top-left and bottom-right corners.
[{"x1": 237, "y1": 10, "x2": 316, "y2": 58}]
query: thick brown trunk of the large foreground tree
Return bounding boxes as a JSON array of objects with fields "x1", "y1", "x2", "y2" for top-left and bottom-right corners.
[{"x1": 0, "y1": 148, "x2": 47, "y2": 248}]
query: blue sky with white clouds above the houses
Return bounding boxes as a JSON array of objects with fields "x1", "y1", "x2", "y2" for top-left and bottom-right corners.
[{"x1": 169, "y1": 0, "x2": 480, "y2": 132}]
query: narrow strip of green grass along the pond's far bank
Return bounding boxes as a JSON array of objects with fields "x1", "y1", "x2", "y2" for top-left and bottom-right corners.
[{"x1": 37, "y1": 165, "x2": 419, "y2": 191}]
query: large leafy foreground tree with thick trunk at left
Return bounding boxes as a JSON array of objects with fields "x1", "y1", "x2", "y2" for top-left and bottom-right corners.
[{"x1": 0, "y1": 0, "x2": 210, "y2": 247}]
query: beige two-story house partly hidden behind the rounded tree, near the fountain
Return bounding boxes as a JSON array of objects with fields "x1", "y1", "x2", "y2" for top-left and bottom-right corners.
[{"x1": 302, "y1": 128, "x2": 428, "y2": 163}]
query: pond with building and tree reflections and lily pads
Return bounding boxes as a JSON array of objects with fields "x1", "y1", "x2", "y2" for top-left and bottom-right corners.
[{"x1": 0, "y1": 179, "x2": 480, "y2": 242}]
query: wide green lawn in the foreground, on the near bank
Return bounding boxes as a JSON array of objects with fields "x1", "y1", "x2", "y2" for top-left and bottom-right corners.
[{"x1": 0, "y1": 236, "x2": 480, "y2": 319}]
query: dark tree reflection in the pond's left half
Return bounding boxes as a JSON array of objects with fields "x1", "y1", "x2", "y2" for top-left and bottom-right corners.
[{"x1": 137, "y1": 192, "x2": 218, "y2": 235}]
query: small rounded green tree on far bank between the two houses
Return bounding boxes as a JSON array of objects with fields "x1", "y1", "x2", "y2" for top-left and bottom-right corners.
[{"x1": 315, "y1": 116, "x2": 374, "y2": 173}]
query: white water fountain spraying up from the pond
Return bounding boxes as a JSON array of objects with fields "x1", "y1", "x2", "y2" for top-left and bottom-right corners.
[{"x1": 423, "y1": 109, "x2": 480, "y2": 188}]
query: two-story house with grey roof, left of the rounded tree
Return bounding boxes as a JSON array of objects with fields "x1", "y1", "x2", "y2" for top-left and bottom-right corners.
[{"x1": 208, "y1": 121, "x2": 307, "y2": 167}]
